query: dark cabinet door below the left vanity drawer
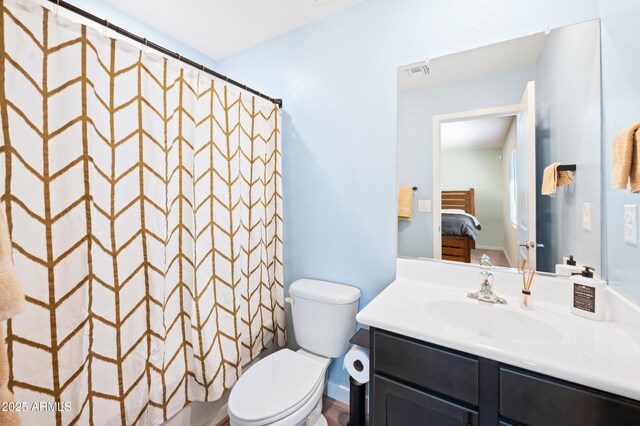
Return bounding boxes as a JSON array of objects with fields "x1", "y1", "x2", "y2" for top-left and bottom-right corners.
[{"x1": 373, "y1": 375, "x2": 478, "y2": 426}]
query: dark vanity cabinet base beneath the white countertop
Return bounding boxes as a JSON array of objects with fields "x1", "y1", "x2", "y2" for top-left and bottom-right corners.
[{"x1": 369, "y1": 329, "x2": 640, "y2": 426}]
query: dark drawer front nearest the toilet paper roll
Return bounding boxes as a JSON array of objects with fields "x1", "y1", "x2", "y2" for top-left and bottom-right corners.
[{"x1": 373, "y1": 330, "x2": 478, "y2": 406}]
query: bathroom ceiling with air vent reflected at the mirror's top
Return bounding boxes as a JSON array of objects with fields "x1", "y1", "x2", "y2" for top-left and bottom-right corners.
[{"x1": 398, "y1": 32, "x2": 546, "y2": 91}]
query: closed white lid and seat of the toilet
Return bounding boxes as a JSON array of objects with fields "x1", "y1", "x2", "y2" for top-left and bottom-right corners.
[{"x1": 228, "y1": 349, "x2": 329, "y2": 426}]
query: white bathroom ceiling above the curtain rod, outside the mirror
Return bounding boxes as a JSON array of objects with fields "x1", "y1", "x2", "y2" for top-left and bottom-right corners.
[{"x1": 92, "y1": 0, "x2": 362, "y2": 60}]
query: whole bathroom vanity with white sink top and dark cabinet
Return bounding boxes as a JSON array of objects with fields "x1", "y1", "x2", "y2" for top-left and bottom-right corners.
[{"x1": 358, "y1": 259, "x2": 640, "y2": 426}]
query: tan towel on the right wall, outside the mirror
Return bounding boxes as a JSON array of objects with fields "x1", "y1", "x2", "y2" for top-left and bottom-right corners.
[{"x1": 613, "y1": 123, "x2": 640, "y2": 192}]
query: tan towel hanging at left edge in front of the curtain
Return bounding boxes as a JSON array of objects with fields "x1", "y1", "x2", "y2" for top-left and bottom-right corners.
[{"x1": 0, "y1": 206, "x2": 24, "y2": 426}]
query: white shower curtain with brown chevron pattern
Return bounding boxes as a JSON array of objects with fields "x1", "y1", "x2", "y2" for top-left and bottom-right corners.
[{"x1": 0, "y1": 0, "x2": 284, "y2": 425}]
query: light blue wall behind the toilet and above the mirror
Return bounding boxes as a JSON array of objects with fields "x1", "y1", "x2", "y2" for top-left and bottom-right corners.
[{"x1": 218, "y1": 0, "x2": 612, "y2": 397}]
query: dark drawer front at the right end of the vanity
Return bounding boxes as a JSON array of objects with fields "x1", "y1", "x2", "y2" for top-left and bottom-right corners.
[{"x1": 500, "y1": 367, "x2": 640, "y2": 426}]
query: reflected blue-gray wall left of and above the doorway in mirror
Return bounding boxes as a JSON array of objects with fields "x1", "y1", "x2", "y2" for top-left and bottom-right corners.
[{"x1": 397, "y1": 64, "x2": 536, "y2": 257}]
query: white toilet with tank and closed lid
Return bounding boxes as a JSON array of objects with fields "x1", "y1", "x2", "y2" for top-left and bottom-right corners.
[{"x1": 228, "y1": 279, "x2": 360, "y2": 426}]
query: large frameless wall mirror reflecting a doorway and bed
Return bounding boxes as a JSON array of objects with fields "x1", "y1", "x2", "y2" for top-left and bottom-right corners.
[{"x1": 397, "y1": 20, "x2": 602, "y2": 273}]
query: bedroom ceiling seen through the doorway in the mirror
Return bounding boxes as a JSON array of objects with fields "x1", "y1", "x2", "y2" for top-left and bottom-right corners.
[{"x1": 440, "y1": 115, "x2": 514, "y2": 150}]
